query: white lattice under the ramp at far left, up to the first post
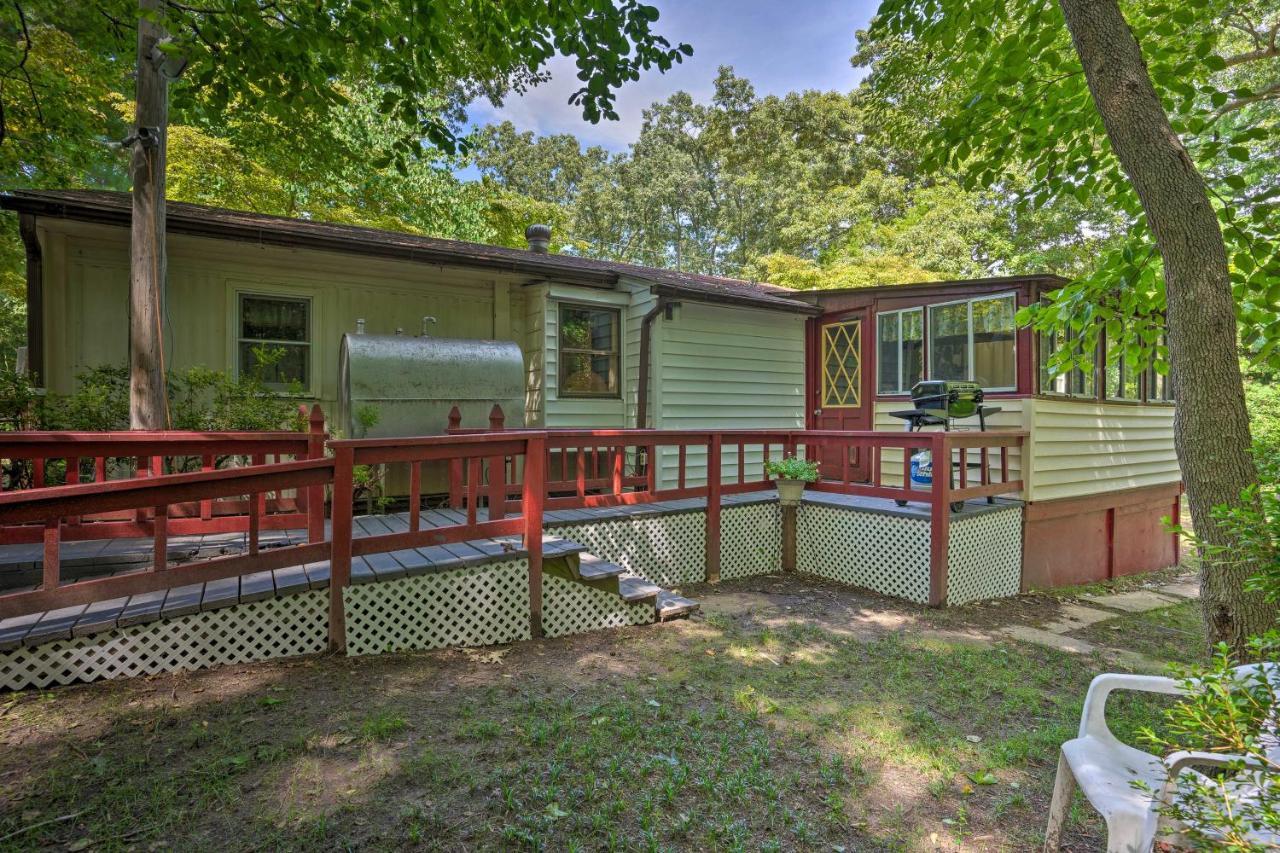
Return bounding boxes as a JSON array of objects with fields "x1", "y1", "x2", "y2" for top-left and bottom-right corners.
[{"x1": 0, "y1": 590, "x2": 329, "y2": 690}]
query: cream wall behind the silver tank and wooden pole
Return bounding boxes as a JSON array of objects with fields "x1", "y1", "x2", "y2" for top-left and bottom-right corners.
[{"x1": 45, "y1": 220, "x2": 529, "y2": 433}]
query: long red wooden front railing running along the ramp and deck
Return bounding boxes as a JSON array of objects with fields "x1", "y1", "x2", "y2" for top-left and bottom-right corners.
[{"x1": 0, "y1": 410, "x2": 1025, "y2": 649}]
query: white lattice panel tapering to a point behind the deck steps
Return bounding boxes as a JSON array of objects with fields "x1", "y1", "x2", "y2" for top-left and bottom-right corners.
[{"x1": 547, "y1": 510, "x2": 706, "y2": 588}]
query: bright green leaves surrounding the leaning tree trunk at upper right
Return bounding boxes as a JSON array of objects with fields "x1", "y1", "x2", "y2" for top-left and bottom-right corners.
[{"x1": 855, "y1": 0, "x2": 1280, "y2": 369}]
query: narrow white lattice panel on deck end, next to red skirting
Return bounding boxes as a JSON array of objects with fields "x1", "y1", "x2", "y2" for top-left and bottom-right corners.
[{"x1": 947, "y1": 506, "x2": 1023, "y2": 605}]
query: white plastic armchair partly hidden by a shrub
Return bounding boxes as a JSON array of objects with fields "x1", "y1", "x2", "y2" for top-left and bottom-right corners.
[{"x1": 1044, "y1": 663, "x2": 1280, "y2": 853}]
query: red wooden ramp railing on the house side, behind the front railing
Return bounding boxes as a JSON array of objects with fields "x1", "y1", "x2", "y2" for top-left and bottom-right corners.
[{"x1": 0, "y1": 406, "x2": 328, "y2": 544}]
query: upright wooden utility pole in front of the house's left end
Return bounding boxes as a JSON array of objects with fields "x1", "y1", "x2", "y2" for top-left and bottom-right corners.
[{"x1": 129, "y1": 0, "x2": 169, "y2": 429}]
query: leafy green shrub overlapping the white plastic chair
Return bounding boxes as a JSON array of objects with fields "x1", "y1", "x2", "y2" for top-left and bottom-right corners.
[{"x1": 1140, "y1": 633, "x2": 1280, "y2": 850}]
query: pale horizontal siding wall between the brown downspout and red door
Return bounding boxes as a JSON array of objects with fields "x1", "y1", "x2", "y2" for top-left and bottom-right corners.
[{"x1": 654, "y1": 302, "x2": 805, "y2": 485}]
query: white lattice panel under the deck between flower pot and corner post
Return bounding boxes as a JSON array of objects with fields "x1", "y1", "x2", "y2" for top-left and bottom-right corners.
[{"x1": 796, "y1": 503, "x2": 929, "y2": 605}]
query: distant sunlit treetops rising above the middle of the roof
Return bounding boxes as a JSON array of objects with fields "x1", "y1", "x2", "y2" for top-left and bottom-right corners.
[{"x1": 474, "y1": 67, "x2": 1110, "y2": 281}]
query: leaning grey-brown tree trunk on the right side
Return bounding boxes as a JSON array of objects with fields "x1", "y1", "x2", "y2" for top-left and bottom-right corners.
[{"x1": 1060, "y1": 0, "x2": 1276, "y2": 657}]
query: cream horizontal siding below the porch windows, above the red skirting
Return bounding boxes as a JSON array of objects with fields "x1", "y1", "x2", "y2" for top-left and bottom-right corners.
[{"x1": 1028, "y1": 398, "x2": 1181, "y2": 501}]
